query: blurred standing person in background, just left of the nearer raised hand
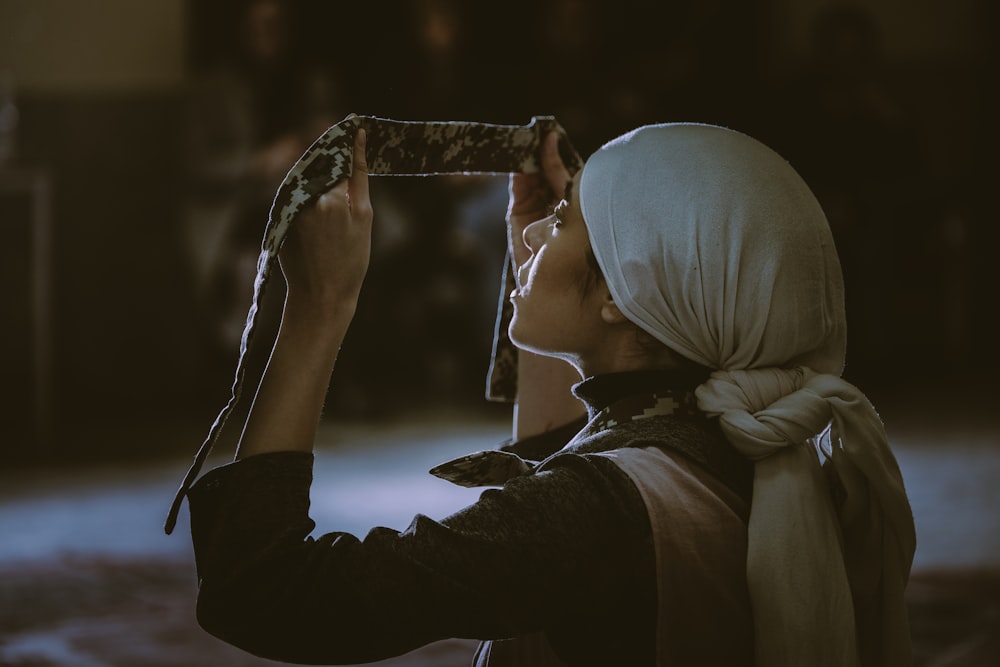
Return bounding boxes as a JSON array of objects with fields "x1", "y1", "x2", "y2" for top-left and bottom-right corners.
[{"x1": 183, "y1": 0, "x2": 343, "y2": 357}]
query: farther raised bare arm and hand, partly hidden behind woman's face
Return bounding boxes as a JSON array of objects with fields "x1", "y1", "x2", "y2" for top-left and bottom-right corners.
[{"x1": 507, "y1": 132, "x2": 585, "y2": 438}]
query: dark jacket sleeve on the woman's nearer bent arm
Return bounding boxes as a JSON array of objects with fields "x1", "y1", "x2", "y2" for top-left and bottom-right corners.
[{"x1": 189, "y1": 452, "x2": 655, "y2": 664}]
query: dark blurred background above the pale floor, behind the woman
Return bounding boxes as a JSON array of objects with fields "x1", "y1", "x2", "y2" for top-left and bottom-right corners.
[{"x1": 0, "y1": 0, "x2": 1000, "y2": 465}]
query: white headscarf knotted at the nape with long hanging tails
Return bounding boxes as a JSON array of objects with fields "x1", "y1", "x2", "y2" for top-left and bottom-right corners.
[{"x1": 580, "y1": 124, "x2": 916, "y2": 667}]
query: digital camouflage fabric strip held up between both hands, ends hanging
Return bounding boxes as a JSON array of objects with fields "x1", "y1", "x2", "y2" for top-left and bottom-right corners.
[{"x1": 164, "y1": 116, "x2": 583, "y2": 534}]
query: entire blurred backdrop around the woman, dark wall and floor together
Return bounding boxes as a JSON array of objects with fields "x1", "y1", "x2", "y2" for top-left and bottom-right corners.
[{"x1": 0, "y1": 0, "x2": 1000, "y2": 667}]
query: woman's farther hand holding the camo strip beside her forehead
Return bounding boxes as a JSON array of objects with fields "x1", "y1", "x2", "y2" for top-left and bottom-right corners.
[{"x1": 507, "y1": 132, "x2": 571, "y2": 268}]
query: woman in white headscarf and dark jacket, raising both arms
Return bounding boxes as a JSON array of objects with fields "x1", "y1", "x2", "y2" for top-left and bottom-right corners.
[{"x1": 189, "y1": 125, "x2": 914, "y2": 665}]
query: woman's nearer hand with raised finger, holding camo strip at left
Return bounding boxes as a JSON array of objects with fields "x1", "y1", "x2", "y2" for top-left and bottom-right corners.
[{"x1": 279, "y1": 129, "x2": 373, "y2": 314}]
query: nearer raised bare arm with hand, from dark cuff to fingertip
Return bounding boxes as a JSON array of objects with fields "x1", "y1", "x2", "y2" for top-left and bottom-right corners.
[{"x1": 236, "y1": 130, "x2": 372, "y2": 459}]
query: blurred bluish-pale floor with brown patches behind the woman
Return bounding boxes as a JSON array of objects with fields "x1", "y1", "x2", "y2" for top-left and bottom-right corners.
[{"x1": 0, "y1": 411, "x2": 1000, "y2": 667}]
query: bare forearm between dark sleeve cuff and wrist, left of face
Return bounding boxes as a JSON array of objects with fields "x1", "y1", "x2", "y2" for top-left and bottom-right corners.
[{"x1": 236, "y1": 295, "x2": 354, "y2": 459}]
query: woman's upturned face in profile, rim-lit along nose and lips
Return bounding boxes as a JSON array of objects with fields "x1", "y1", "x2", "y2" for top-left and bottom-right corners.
[{"x1": 509, "y1": 176, "x2": 601, "y2": 357}]
